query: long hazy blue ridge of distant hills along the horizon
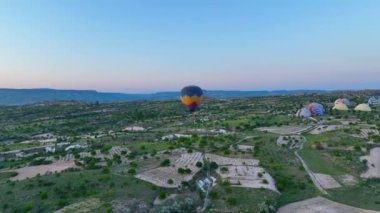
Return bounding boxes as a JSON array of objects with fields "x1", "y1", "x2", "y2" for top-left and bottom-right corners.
[{"x1": 0, "y1": 89, "x2": 326, "y2": 105}]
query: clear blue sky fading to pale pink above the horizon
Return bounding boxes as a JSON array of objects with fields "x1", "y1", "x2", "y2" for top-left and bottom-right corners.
[{"x1": 0, "y1": 0, "x2": 380, "y2": 92}]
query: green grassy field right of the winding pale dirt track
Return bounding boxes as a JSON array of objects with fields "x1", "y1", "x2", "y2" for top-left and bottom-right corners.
[{"x1": 300, "y1": 131, "x2": 380, "y2": 210}]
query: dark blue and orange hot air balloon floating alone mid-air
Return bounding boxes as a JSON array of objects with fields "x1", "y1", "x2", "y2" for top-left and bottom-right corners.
[{"x1": 180, "y1": 86, "x2": 203, "y2": 112}]
